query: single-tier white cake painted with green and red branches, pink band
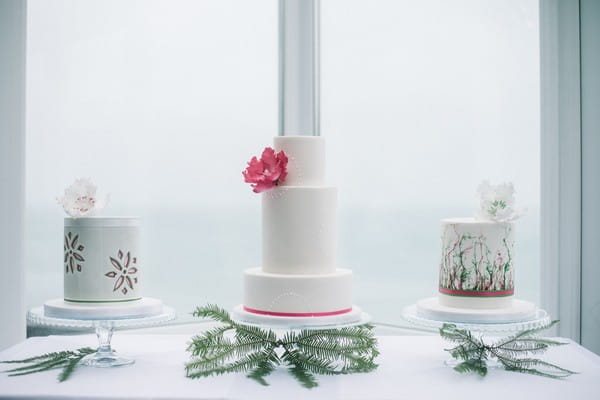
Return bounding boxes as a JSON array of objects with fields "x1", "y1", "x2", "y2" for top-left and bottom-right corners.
[{"x1": 438, "y1": 218, "x2": 514, "y2": 309}]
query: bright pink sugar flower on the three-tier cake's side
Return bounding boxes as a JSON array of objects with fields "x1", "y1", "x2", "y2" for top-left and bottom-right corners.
[{"x1": 242, "y1": 147, "x2": 288, "y2": 193}]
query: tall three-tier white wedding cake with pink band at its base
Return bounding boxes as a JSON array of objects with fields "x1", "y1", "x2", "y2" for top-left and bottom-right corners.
[{"x1": 243, "y1": 136, "x2": 353, "y2": 317}]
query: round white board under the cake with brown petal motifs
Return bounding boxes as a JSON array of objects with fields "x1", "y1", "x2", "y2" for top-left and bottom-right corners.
[{"x1": 44, "y1": 297, "x2": 163, "y2": 319}]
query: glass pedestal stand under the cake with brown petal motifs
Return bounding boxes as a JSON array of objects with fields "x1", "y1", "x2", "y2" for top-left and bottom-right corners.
[{"x1": 27, "y1": 306, "x2": 177, "y2": 368}]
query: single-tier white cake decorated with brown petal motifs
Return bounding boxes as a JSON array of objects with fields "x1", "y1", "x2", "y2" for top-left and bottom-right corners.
[{"x1": 63, "y1": 217, "x2": 142, "y2": 303}]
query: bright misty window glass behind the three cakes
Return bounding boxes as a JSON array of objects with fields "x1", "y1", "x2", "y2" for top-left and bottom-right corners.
[{"x1": 26, "y1": 0, "x2": 539, "y2": 324}]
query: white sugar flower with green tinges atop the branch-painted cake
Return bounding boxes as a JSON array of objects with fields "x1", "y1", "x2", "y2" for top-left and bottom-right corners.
[{"x1": 477, "y1": 180, "x2": 523, "y2": 222}]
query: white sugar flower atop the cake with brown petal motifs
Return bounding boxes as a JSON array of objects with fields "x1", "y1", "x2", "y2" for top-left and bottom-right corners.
[{"x1": 57, "y1": 178, "x2": 109, "y2": 217}]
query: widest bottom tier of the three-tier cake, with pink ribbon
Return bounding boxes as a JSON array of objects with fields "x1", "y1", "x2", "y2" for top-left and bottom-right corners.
[{"x1": 244, "y1": 268, "x2": 352, "y2": 317}]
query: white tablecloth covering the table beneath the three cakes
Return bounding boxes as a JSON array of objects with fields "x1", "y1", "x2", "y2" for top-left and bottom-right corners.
[{"x1": 0, "y1": 334, "x2": 600, "y2": 400}]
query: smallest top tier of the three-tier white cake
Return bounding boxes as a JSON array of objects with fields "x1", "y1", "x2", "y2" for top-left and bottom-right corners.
[{"x1": 274, "y1": 136, "x2": 325, "y2": 186}]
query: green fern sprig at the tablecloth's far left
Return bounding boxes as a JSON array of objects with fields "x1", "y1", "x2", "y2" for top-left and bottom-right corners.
[{"x1": 0, "y1": 347, "x2": 96, "y2": 382}]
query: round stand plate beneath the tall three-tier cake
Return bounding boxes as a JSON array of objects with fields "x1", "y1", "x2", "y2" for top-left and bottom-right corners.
[{"x1": 232, "y1": 304, "x2": 371, "y2": 330}]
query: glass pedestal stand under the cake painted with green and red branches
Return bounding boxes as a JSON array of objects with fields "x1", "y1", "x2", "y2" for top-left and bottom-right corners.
[{"x1": 402, "y1": 304, "x2": 552, "y2": 368}]
